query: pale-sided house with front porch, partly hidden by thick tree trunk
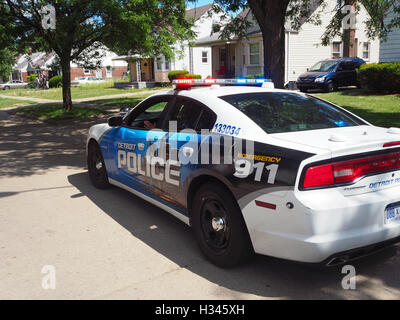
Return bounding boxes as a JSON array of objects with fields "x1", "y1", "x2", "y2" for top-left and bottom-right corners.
[{"x1": 196, "y1": 1, "x2": 379, "y2": 82}]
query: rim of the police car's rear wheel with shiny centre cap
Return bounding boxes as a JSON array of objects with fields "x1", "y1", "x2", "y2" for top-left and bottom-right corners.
[{"x1": 200, "y1": 198, "x2": 230, "y2": 252}]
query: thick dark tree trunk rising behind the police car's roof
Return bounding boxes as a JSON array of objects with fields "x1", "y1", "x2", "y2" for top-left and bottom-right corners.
[{"x1": 249, "y1": 0, "x2": 289, "y2": 88}]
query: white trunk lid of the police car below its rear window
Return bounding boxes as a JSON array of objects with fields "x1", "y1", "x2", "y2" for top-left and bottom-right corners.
[{"x1": 271, "y1": 125, "x2": 400, "y2": 157}]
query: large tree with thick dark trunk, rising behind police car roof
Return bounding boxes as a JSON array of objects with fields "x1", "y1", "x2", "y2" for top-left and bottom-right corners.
[{"x1": 214, "y1": 0, "x2": 400, "y2": 88}]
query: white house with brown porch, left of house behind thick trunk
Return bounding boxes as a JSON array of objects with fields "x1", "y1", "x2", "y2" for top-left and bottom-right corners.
[{"x1": 114, "y1": 4, "x2": 222, "y2": 86}]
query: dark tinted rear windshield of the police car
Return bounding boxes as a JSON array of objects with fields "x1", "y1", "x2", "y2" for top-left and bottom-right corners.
[{"x1": 220, "y1": 92, "x2": 365, "y2": 133}]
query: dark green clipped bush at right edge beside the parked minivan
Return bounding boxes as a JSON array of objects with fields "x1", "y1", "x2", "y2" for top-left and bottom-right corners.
[{"x1": 357, "y1": 62, "x2": 400, "y2": 94}]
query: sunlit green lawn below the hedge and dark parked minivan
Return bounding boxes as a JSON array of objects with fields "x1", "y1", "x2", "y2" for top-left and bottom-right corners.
[{"x1": 316, "y1": 89, "x2": 400, "y2": 127}]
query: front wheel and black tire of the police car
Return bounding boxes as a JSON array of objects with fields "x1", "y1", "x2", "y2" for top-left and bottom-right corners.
[{"x1": 87, "y1": 142, "x2": 110, "y2": 189}]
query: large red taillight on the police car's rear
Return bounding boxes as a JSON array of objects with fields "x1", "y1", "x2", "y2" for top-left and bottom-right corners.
[{"x1": 303, "y1": 152, "x2": 400, "y2": 189}]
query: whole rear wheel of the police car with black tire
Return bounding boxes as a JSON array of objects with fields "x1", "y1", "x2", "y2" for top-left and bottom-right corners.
[{"x1": 191, "y1": 183, "x2": 254, "y2": 268}]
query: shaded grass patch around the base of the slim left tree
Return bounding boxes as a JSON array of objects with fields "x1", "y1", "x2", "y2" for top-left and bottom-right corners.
[{"x1": 17, "y1": 105, "x2": 110, "y2": 120}]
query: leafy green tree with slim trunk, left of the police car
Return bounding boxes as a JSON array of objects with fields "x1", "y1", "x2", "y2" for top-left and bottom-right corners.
[{"x1": 0, "y1": 0, "x2": 193, "y2": 110}]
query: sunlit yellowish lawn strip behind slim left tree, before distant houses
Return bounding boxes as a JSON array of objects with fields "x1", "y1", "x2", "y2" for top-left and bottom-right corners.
[{"x1": 3, "y1": 82, "x2": 166, "y2": 100}]
